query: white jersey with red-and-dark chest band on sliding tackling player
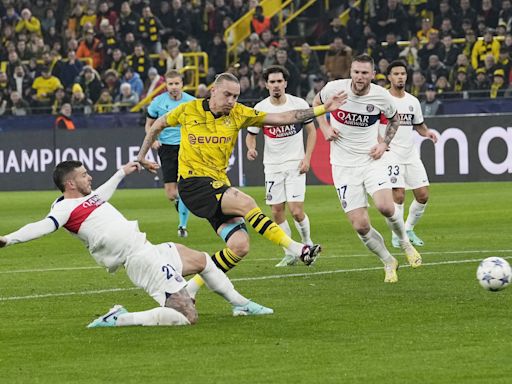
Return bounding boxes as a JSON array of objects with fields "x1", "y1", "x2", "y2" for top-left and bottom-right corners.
[{"x1": 48, "y1": 191, "x2": 146, "y2": 272}]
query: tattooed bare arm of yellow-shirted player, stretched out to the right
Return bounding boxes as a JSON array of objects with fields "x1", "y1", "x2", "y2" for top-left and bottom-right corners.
[{"x1": 263, "y1": 91, "x2": 347, "y2": 125}]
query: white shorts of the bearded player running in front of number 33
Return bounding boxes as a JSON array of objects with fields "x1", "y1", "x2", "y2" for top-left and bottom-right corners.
[{"x1": 332, "y1": 160, "x2": 391, "y2": 212}]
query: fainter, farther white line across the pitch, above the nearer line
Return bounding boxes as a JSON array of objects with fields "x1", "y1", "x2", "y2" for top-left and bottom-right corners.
[{"x1": 0, "y1": 249, "x2": 512, "y2": 275}]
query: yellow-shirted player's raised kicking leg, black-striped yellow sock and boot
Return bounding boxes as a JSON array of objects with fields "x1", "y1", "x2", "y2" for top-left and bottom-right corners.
[{"x1": 221, "y1": 187, "x2": 321, "y2": 265}]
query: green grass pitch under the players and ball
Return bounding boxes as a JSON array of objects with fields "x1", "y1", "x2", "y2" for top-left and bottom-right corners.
[{"x1": 0, "y1": 183, "x2": 512, "y2": 384}]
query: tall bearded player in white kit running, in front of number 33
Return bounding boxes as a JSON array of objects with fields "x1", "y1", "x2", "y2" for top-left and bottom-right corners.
[{"x1": 313, "y1": 54, "x2": 421, "y2": 283}]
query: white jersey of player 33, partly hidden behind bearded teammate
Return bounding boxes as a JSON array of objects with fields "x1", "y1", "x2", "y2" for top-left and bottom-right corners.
[{"x1": 380, "y1": 92, "x2": 424, "y2": 164}]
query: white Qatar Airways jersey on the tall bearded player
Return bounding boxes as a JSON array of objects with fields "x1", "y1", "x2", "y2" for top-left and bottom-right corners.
[{"x1": 320, "y1": 79, "x2": 396, "y2": 167}]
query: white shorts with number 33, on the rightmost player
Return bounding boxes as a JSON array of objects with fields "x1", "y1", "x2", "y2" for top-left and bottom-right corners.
[{"x1": 383, "y1": 152, "x2": 430, "y2": 189}]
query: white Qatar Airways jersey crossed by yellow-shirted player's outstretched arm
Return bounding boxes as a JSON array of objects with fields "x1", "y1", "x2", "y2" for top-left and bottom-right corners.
[{"x1": 248, "y1": 94, "x2": 313, "y2": 173}]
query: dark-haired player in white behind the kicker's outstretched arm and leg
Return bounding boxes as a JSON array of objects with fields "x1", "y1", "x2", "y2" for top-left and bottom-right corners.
[{"x1": 245, "y1": 65, "x2": 316, "y2": 267}]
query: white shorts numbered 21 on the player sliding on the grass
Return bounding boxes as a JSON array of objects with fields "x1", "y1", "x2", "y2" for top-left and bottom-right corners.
[{"x1": 125, "y1": 242, "x2": 187, "y2": 306}]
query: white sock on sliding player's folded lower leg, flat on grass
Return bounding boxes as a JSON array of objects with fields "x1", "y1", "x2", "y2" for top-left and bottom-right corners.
[{"x1": 116, "y1": 307, "x2": 190, "y2": 327}]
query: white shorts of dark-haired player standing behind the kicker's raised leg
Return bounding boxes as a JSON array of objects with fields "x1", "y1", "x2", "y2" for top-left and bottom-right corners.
[{"x1": 265, "y1": 169, "x2": 306, "y2": 205}]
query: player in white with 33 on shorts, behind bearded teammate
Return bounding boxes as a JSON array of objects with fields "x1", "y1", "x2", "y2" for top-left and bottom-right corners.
[{"x1": 380, "y1": 60, "x2": 437, "y2": 248}]
